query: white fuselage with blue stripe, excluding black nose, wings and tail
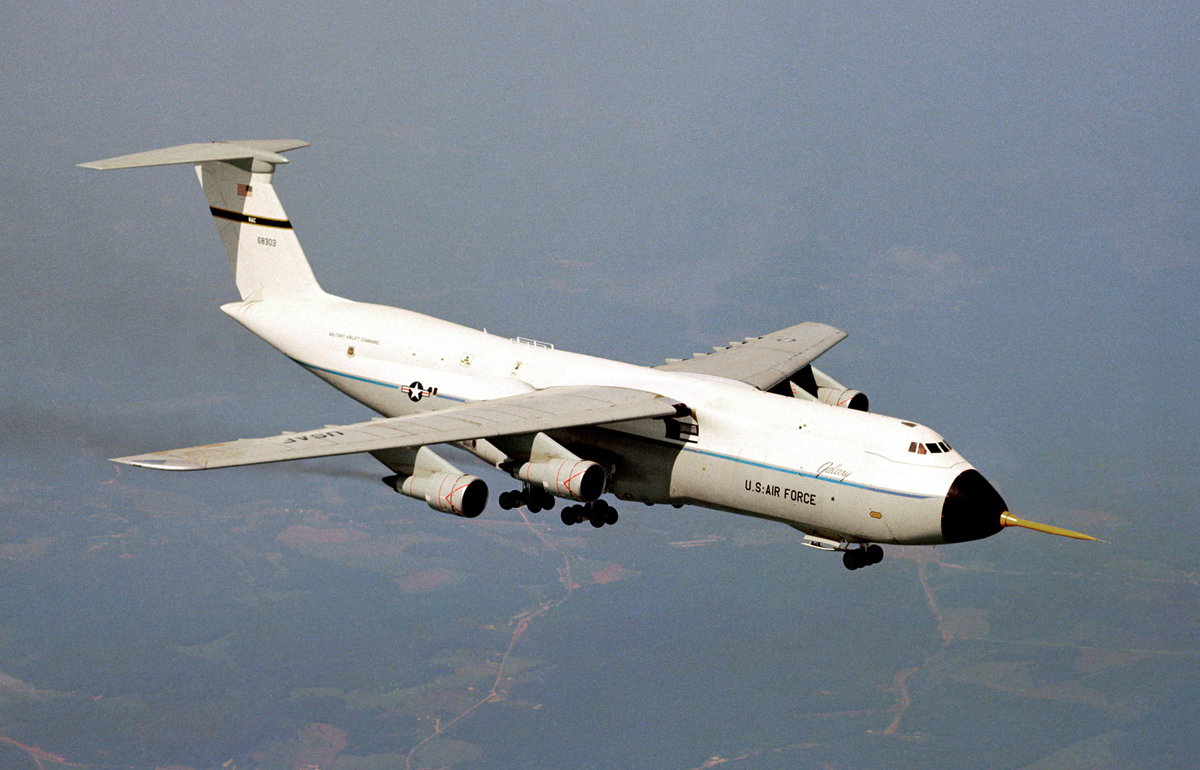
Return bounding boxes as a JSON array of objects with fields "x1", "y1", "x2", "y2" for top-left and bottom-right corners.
[{"x1": 222, "y1": 296, "x2": 971, "y2": 545}]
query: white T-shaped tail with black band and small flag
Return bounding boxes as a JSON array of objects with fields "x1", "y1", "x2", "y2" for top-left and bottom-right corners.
[{"x1": 79, "y1": 139, "x2": 324, "y2": 300}]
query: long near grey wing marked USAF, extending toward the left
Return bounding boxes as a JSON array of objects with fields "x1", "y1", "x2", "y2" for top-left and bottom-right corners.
[{"x1": 114, "y1": 386, "x2": 688, "y2": 470}]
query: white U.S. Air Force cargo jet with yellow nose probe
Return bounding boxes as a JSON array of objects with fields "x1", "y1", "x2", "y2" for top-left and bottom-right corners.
[{"x1": 80, "y1": 140, "x2": 1096, "y2": 570}]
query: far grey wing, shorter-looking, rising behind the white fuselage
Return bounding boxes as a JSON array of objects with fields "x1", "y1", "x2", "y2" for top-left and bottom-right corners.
[{"x1": 655, "y1": 321, "x2": 846, "y2": 390}]
